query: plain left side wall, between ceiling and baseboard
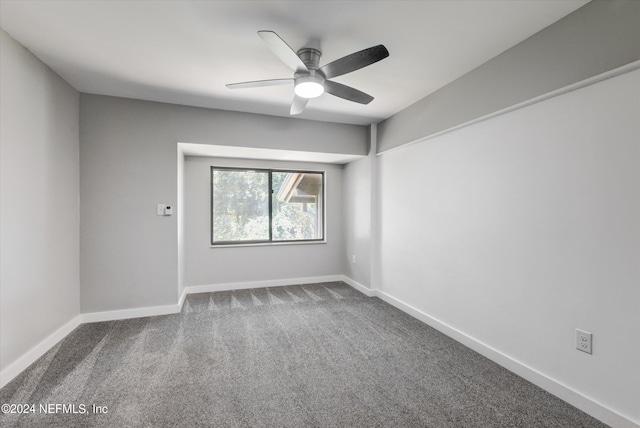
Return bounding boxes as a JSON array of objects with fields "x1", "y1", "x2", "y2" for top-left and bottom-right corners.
[{"x1": 0, "y1": 31, "x2": 80, "y2": 374}]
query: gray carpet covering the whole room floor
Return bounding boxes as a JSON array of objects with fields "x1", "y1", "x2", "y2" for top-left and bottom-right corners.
[{"x1": 0, "y1": 282, "x2": 605, "y2": 428}]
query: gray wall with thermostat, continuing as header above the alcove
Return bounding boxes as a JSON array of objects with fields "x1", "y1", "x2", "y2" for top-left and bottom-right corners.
[{"x1": 80, "y1": 94, "x2": 368, "y2": 312}]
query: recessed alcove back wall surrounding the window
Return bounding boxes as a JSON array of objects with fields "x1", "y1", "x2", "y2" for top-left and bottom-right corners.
[{"x1": 185, "y1": 157, "x2": 344, "y2": 286}]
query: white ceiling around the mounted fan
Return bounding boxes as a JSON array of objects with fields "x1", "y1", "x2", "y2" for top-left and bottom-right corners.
[{"x1": 0, "y1": 0, "x2": 588, "y2": 124}]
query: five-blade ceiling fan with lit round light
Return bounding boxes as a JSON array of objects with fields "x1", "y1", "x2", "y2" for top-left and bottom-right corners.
[{"x1": 226, "y1": 31, "x2": 389, "y2": 115}]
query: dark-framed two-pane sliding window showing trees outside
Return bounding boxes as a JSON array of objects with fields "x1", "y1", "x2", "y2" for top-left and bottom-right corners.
[{"x1": 211, "y1": 166, "x2": 324, "y2": 245}]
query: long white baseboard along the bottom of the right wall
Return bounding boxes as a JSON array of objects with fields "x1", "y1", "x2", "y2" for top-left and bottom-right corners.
[{"x1": 370, "y1": 286, "x2": 640, "y2": 428}]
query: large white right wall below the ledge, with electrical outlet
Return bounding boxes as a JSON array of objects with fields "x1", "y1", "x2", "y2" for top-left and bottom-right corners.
[{"x1": 379, "y1": 71, "x2": 640, "y2": 423}]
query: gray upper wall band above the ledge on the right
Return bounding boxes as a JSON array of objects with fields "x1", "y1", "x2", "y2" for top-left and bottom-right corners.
[{"x1": 378, "y1": 0, "x2": 640, "y2": 153}]
